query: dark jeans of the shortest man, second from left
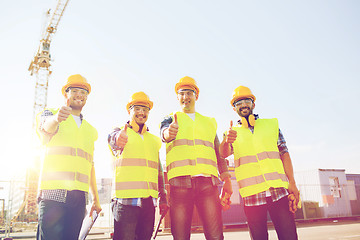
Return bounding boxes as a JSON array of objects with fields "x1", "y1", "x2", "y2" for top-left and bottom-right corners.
[{"x1": 111, "y1": 197, "x2": 155, "y2": 240}]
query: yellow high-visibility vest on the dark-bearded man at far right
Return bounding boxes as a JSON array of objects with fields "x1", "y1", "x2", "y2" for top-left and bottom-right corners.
[{"x1": 233, "y1": 118, "x2": 288, "y2": 197}]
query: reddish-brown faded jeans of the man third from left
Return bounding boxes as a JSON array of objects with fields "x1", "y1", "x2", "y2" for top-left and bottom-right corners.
[{"x1": 170, "y1": 177, "x2": 224, "y2": 240}]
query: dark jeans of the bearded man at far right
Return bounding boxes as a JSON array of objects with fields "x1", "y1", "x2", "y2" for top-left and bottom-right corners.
[{"x1": 244, "y1": 197, "x2": 298, "y2": 240}]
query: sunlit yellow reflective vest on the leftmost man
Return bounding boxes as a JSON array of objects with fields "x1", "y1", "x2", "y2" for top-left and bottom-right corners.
[{"x1": 40, "y1": 109, "x2": 98, "y2": 192}]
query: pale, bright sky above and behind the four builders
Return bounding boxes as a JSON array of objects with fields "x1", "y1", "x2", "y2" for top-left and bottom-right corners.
[{"x1": 0, "y1": 0, "x2": 360, "y2": 180}]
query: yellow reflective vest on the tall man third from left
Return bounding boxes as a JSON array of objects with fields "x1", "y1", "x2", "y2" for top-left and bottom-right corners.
[{"x1": 166, "y1": 112, "x2": 218, "y2": 179}]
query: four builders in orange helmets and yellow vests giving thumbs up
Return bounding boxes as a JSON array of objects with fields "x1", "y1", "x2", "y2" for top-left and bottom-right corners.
[{"x1": 37, "y1": 74, "x2": 299, "y2": 240}]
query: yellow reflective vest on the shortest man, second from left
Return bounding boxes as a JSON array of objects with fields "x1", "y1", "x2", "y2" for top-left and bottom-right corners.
[{"x1": 114, "y1": 128, "x2": 161, "y2": 198}]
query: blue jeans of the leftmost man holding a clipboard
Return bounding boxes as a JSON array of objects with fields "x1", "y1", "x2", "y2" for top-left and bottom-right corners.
[{"x1": 36, "y1": 190, "x2": 86, "y2": 240}]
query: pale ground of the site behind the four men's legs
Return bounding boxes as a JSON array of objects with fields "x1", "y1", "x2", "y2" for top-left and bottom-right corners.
[{"x1": 0, "y1": 217, "x2": 360, "y2": 240}]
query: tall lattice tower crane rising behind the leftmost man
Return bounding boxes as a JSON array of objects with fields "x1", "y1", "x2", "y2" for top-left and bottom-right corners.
[{"x1": 12, "y1": 0, "x2": 69, "y2": 222}]
